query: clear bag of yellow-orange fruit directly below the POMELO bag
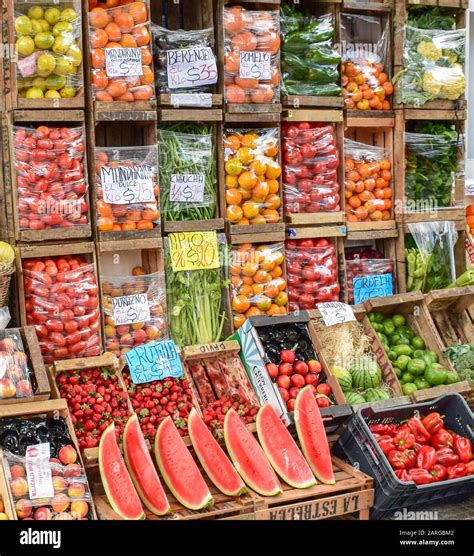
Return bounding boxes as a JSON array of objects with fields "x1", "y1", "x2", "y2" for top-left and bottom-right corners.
[{"x1": 224, "y1": 128, "x2": 281, "y2": 225}]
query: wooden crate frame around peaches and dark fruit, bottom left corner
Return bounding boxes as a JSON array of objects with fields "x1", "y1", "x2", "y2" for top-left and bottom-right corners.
[{"x1": 0, "y1": 400, "x2": 97, "y2": 519}]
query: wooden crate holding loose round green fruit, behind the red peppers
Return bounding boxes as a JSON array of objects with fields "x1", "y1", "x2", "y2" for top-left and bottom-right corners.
[{"x1": 364, "y1": 292, "x2": 470, "y2": 403}]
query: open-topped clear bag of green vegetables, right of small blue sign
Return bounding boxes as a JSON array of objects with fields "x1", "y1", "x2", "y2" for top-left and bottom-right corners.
[{"x1": 405, "y1": 221, "x2": 458, "y2": 293}]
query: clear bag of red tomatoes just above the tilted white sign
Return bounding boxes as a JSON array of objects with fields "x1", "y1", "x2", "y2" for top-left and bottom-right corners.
[{"x1": 285, "y1": 238, "x2": 341, "y2": 313}]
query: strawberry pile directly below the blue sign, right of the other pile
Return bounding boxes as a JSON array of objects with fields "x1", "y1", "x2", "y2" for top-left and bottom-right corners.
[{"x1": 123, "y1": 369, "x2": 193, "y2": 442}]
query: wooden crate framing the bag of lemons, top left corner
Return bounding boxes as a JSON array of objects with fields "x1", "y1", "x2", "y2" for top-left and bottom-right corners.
[{"x1": 2, "y1": 0, "x2": 85, "y2": 112}]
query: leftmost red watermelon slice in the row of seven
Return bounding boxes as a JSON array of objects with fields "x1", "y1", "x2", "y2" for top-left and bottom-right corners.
[{"x1": 99, "y1": 423, "x2": 145, "y2": 519}]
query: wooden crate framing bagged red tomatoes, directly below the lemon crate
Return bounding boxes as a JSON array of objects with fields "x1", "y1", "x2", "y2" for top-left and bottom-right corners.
[{"x1": 2, "y1": 111, "x2": 92, "y2": 243}]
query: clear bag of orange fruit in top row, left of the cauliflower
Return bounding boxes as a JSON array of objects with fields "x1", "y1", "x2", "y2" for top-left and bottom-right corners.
[{"x1": 341, "y1": 13, "x2": 393, "y2": 110}]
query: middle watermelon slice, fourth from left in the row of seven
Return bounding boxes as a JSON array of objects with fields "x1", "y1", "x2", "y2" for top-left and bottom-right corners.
[{"x1": 188, "y1": 408, "x2": 247, "y2": 496}]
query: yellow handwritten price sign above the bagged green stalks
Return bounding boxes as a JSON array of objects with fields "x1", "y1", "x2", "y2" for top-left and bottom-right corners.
[{"x1": 168, "y1": 232, "x2": 220, "y2": 272}]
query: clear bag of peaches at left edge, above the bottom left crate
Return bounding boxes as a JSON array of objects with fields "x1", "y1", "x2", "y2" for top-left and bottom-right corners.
[{"x1": 0, "y1": 329, "x2": 33, "y2": 399}]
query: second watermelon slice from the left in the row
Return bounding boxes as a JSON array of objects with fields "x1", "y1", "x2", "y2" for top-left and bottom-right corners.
[{"x1": 123, "y1": 413, "x2": 171, "y2": 515}]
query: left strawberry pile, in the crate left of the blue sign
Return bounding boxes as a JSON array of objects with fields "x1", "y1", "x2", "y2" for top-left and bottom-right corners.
[{"x1": 56, "y1": 368, "x2": 130, "y2": 450}]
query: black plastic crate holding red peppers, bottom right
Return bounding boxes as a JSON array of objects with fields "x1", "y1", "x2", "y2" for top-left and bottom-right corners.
[{"x1": 333, "y1": 394, "x2": 474, "y2": 519}]
